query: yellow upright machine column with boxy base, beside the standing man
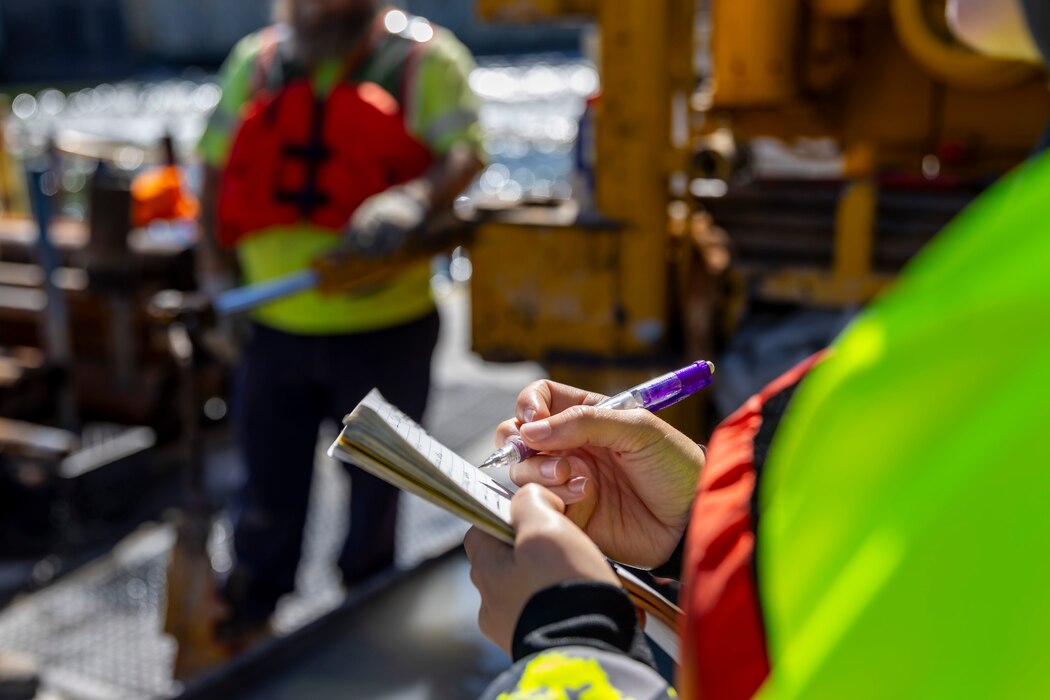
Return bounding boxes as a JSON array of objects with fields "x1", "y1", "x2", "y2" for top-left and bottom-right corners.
[{"x1": 471, "y1": 0, "x2": 709, "y2": 430}]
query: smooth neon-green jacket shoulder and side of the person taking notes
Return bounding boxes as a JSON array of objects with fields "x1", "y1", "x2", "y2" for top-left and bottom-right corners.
[{"x1": 757, "y1": 155, "x2": 1050, "y2": 698}]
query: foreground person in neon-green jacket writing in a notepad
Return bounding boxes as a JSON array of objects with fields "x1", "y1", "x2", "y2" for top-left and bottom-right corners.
[{"x1": 465, "y1": 0, "x2": 1050, "y2": 699}]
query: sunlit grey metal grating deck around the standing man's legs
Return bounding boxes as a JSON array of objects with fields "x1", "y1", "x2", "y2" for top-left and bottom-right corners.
[{"x1": 0, "y1": 287, "x2": 540, "y2": 700}]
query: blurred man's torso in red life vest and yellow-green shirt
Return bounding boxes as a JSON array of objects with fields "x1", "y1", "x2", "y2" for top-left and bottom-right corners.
[{"x1": 218, "y1": 15, "x2": 445, "y2": 334}]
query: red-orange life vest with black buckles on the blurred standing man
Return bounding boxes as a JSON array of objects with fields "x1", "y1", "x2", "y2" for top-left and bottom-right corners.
[{"x1": 218, "y1": 25, "x2": 433, "y2": 247}]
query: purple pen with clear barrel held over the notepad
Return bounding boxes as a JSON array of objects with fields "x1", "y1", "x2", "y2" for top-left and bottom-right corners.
[{"x1": 479, "y1": 360, "x2": 715, "y2": 469}]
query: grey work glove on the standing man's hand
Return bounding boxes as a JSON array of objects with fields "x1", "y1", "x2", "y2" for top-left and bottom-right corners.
[{"x1": 345, "y1": 187, "x2": 426, "y2": 259}]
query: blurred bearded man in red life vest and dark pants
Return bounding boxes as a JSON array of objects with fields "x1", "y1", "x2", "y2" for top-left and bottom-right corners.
[{"x1": 200, "y1": 0, "x2": 481, "y2": 641}]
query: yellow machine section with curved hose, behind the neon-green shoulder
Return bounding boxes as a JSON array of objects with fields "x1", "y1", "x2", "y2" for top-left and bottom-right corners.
[{"x1": 698, "y1": 0, "x2": 1050, "y2": 305}]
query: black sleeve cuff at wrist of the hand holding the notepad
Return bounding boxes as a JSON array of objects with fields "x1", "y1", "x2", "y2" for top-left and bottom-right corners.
[{"x1": 511, "y1": 581, "x2": 654, "y2": 666}]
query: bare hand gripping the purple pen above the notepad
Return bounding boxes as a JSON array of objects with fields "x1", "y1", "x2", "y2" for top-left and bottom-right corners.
[{"x1": 480, "y1": 363, "x2": 710, "y2": 567}]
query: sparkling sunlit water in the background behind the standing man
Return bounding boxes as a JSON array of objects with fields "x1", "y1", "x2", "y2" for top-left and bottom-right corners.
[{"x1": 4, "y1": 56, "x2": 599, "y2": 209}]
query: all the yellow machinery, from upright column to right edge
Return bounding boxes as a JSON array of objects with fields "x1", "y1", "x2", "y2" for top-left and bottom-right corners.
[{"x1": 471, "y1": 0, "x2": 1050, "y2": 427}]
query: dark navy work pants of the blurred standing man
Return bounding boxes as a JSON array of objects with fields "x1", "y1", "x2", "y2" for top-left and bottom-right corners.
[{"x1": 225, "y1": 312, "x2": 439, "y2": 621}]
